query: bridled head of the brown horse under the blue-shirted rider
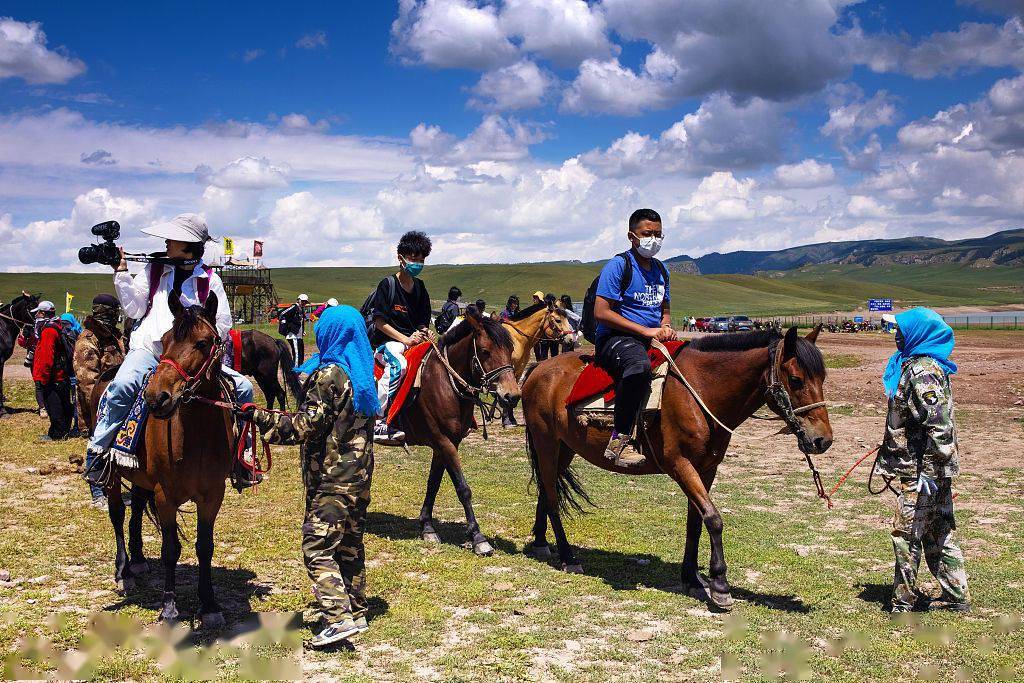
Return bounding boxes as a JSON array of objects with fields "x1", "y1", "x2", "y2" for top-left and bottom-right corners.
[{"x1": 768, "y1": 325, "x2": 833, "y2": 454}]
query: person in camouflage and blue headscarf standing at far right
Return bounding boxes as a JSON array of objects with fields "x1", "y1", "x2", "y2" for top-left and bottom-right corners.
[{"x1": 877, "y1": 308, "x2": 970, "y2": 612}]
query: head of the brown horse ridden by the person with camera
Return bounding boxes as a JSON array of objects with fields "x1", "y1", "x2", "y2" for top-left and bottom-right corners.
[{"x1": 144, "y1": 294, "x2": 220, "y2": 418}]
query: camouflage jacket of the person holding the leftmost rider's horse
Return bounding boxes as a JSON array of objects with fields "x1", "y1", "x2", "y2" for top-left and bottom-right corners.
[{"x1": 253, "y1": 366, "x2": 375, "y2": 494}]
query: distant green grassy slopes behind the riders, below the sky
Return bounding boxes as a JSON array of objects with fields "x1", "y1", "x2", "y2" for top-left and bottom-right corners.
[{"x1": 0, "y1": 262, "x2": 1024, "y2": 315}]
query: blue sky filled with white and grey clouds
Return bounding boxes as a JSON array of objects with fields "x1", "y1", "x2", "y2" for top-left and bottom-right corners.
[{"x1": 0, "y1": 0, "x2": 1024, "y2": 269}]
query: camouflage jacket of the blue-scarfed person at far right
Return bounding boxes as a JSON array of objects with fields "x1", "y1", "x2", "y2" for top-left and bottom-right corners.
[{"x1": 879, "y1": 356, "x2": 959, "y2": 479}]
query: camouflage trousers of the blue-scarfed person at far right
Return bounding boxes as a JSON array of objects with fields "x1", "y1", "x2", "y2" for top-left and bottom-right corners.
[{"x1": 893, "y1": 478, "x2": 970, "y2": 608}]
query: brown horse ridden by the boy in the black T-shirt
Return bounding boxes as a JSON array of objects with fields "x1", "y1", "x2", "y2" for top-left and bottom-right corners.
[{"x1": 393, "y1": 306, "x2": 519, "y2": 555}]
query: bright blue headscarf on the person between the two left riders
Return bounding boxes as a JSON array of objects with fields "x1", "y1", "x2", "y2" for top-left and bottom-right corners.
[{"x1": 294, "y1": 306, "x2": 380, "y2": 416}]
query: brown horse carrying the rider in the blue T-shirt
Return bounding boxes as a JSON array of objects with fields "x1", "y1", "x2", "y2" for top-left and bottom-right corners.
[{"x1": 522, "y1": 328, "x2": 831, "y2": 609}]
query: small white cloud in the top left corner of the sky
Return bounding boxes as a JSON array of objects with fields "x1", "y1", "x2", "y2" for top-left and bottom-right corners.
[{"x1": 0, "y1": 16, "x2": 85, "y2": 83}]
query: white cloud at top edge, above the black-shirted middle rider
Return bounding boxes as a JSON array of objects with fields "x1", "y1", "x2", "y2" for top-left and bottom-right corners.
[{"x1": 391, "y1": 0, "x2": 516, "y2": 69}]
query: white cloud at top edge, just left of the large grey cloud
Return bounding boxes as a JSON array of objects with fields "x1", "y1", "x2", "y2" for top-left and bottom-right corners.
[{"x1": 499, "y1": 0, "x2": 618, "y2": 67}]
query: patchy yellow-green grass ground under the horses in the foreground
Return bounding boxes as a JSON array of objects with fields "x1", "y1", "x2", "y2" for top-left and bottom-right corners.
[{"x1": 0, "y1": 359, "x2": 1024, "y2": 682}]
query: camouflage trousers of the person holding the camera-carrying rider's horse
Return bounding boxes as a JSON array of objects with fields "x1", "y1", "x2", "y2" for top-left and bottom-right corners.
[{"x1": 302, "y1": 450, "x2": 373, "y2": 624}]
